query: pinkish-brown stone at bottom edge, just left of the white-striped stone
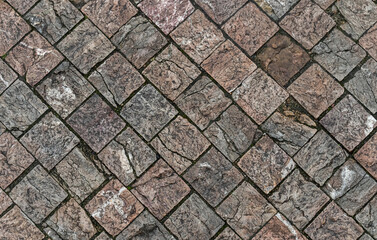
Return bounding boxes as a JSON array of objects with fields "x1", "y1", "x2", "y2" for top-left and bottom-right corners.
[{"x1": 216, "y1": 182, "x2": 276, "y2": 239}]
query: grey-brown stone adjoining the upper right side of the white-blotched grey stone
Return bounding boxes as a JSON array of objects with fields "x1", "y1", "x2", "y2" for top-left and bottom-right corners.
[{"x1": 57, "y1": 19, "x2": 115, "y2": 74}]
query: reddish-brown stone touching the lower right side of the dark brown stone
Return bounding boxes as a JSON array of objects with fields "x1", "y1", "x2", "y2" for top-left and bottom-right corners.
[{"x1": 288, "y1": 64, "x2": 344, "y2": 118}]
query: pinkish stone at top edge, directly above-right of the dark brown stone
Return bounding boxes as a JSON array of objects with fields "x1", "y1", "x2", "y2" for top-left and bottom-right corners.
[{"x1": 280, "y1": 0, "x2": 335, "y2": 50}]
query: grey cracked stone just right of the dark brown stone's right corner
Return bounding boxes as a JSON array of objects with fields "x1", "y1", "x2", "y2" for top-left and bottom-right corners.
[{"x1": 312, "y1": 29, "x2": 366, "y2": 81}]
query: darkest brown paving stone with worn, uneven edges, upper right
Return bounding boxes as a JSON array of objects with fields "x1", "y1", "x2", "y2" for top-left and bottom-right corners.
[{"x1": 257, "y1": 34, "x2": 310, "y2": 86}]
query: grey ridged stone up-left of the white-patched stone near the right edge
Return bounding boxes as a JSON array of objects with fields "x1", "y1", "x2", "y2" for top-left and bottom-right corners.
[{"x1": 294, "y1": 130, "x2": 348, "y2": 186}]
